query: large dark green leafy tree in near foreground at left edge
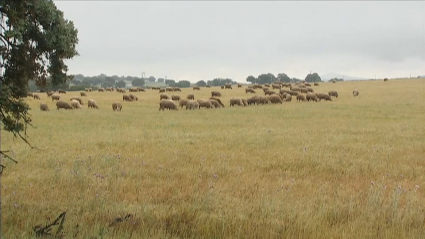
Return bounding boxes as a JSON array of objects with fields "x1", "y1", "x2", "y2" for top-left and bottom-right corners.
[{"x1": 0, "y1": 0, "x2": 78, "y2": 139}]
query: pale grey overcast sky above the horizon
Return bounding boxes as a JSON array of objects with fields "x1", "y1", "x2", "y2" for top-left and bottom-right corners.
[{"x1": 55, "y1": 0, "x2": 425, "y2": 82}]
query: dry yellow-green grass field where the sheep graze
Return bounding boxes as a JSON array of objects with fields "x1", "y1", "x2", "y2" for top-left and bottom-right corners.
[{"x1": 1, "y1": 79, "x2": 425, "y2": 238}]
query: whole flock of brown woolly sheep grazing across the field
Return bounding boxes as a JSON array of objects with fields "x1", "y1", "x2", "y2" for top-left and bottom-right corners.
[{"x1": 27, "y1": 82, "x2": 359, "y2": 111}]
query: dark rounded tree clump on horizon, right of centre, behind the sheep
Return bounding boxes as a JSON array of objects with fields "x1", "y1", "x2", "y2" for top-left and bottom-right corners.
[{"x1": 246, "y1": 73, "x2": 322, "y2": 84}]
